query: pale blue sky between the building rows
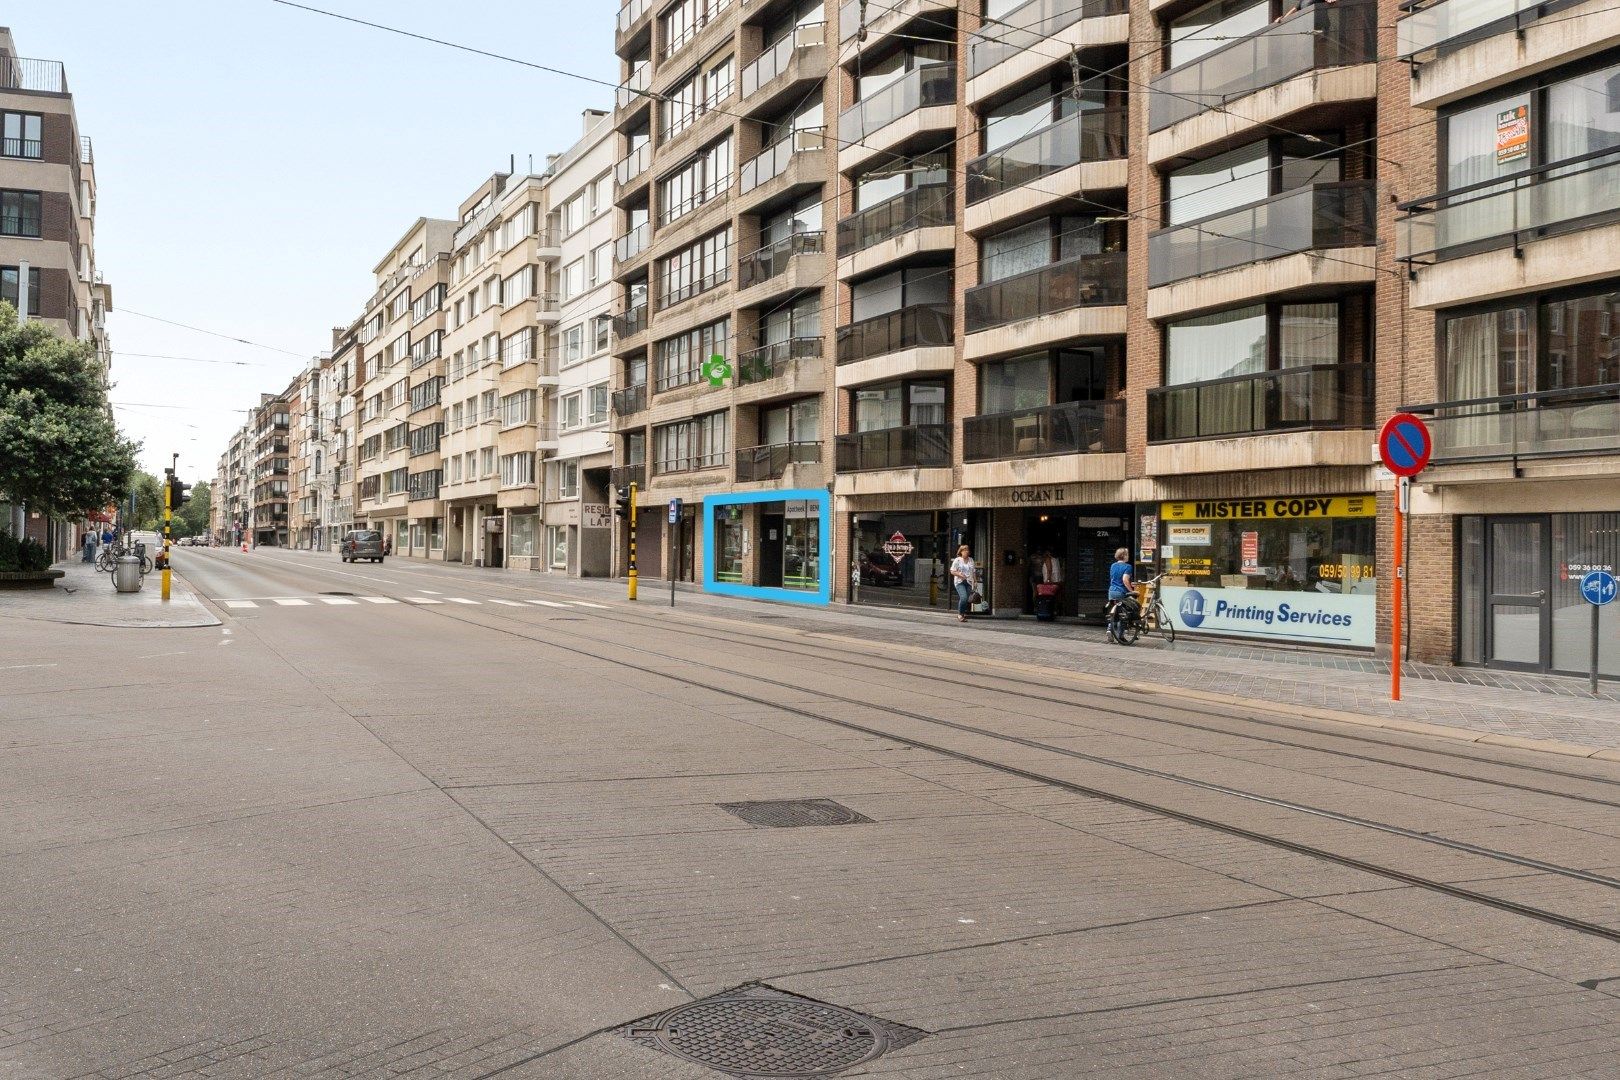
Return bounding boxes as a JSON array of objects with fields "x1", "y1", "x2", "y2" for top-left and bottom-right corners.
[{"x1": 19, "y1": 0, "x2": 617, "y2": 483}]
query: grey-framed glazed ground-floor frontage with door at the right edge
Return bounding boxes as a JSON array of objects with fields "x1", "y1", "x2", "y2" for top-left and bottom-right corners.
[{"x1": 1458, "y1": 513, "x2": 1620, "y2": 678}]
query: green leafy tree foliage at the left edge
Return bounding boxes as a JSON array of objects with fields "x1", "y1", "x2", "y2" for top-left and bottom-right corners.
[{"x1": 0, "y1": 304, "x2": 139, "y2": 515}]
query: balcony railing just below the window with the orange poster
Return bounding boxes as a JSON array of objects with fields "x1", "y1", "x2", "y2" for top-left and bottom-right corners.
[{"x1": 1395, "y1": 149, "x2": 1620, "y2": 261}]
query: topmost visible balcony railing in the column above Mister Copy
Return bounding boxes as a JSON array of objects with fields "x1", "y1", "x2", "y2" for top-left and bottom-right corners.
[{"x1": 1147, "y1": 0, "x2": 1379, "y2": 131}]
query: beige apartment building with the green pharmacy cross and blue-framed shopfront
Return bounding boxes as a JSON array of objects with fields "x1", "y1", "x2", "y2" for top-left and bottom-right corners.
[{"x1": 612, "y1": 0, "x2": 839, "y2": 602}]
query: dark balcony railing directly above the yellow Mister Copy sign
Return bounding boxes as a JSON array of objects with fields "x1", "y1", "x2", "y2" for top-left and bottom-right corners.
[{"x1": 1147, "y1": 364, "x2": 1372, "y2": 442}]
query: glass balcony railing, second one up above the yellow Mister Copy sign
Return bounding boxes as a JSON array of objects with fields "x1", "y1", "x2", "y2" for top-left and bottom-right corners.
[{"x1": 1147, "y1": 180, "x2": 1377, "y2": 287}]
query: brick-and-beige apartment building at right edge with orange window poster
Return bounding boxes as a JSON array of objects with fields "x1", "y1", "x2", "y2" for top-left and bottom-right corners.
[{"x1": 1379, "y1": 0, "x2": 1620, "y2": 678}]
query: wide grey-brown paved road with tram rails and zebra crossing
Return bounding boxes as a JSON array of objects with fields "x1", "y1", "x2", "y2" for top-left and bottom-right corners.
[{"x1": 9, "y1": 551, "x2": 1620, "y2": 1080}]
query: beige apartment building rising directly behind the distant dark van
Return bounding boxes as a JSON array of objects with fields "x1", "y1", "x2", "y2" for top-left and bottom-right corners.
[{"x1": 355, "y1": 217, "x2": 455, "y2": 559}]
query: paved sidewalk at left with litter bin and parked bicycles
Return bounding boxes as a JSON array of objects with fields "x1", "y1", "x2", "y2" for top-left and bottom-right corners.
[{"x1": 0, "y1": 559, "x2": 219, "y2": 628}]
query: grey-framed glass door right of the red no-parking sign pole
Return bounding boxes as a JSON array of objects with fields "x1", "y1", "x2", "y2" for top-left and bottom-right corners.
[{"x1": 1486, "y1": 517, "x2": 1552, "y2": 670}]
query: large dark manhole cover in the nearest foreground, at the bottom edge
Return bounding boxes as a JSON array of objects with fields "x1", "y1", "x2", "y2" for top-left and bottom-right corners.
[{"x1": 620, "y1": 986, "x2": 927, "y2": 1077}]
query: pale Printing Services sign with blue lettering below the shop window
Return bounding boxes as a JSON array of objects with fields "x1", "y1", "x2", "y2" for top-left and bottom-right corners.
[{"x1": 1163, "y1": 586, "x2": 1377, "y2": 649}]
